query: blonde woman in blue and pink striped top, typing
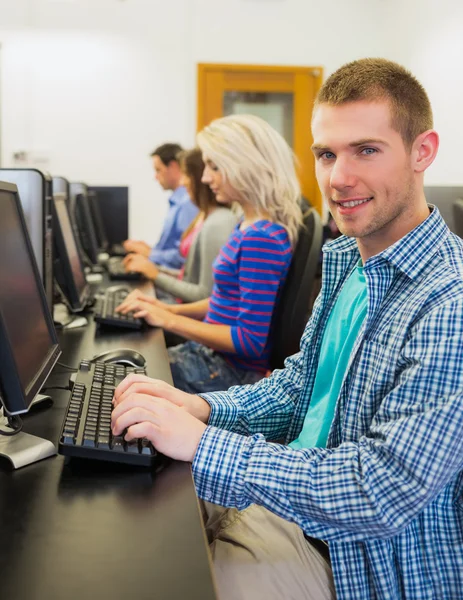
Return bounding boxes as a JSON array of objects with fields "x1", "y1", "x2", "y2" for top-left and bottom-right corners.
[{"x1": 119, "y1": 115, "x2": 302, "y2": 393}]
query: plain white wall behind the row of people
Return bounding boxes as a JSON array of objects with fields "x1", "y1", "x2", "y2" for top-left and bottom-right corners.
[{"x1": 0, "y1": 0, "x2": 463, "y2": 241}]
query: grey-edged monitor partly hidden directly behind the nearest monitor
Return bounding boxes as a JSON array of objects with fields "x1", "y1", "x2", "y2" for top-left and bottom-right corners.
[{"x1": 0, "y1": 169, "x2": 53, "y2": 310}]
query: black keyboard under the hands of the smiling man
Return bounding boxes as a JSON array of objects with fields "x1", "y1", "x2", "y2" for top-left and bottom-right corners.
[{"x1": 58, "y1": 360, "x2": 160, "y2": 467}]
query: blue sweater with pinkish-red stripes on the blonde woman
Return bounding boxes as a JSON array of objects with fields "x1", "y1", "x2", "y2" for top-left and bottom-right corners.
[{"x1": 205, "y1": 220, "x2": 292, "y2": 372}]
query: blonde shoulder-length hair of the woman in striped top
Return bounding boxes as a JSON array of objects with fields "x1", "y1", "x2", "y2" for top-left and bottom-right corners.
[{"x1": 197, "y1": 115, "x2": 302, "y2": 247}]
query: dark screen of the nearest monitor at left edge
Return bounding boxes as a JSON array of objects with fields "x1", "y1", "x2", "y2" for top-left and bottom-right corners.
[{"x1": 0, "y1": 183, "x2": 61, "y2": 414}]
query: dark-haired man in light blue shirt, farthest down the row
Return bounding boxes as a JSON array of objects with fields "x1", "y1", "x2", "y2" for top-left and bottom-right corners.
[{"x1": 124, "y1": 144, "x2": 198, "y2": 271}]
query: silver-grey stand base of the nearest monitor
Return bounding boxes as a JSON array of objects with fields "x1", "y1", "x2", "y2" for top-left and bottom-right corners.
[{"x1": 0, "y1": 395, "x2": 56, "y2": 469}]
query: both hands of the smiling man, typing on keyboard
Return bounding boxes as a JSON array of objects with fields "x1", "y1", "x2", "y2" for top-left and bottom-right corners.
[{"x1": 111, "y1": 375, "x2": 210, "y2": 462}]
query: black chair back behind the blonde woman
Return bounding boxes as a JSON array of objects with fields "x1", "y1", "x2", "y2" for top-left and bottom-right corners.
[{"x1": 270, "y1": 208, "x2": 323, "y2": 370}]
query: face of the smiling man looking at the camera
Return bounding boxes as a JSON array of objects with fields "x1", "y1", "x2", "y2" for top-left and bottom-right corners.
[{"x1": 312, "y1": 101, "x2": 419, "y2": 251}]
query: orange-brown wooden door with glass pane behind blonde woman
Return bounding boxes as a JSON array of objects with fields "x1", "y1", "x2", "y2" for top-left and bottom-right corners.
[{"x1": 198, "y1": 64, "x2": 323, "y2": 214}]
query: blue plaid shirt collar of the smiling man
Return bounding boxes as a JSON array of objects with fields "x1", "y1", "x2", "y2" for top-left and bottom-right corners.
[{"x1": 323, "y1": 205, "x2": 450, "y2": 280}]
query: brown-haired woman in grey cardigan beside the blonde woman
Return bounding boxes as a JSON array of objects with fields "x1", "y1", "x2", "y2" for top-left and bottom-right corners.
[{"x1": 127, "y1": 148, "x2": 238, "y2": 302}]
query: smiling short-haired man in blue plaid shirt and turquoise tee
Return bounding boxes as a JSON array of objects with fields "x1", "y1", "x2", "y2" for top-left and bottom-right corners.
[{"x1": 109, "y1": 59, "x2": 463, "y2": 600}]
